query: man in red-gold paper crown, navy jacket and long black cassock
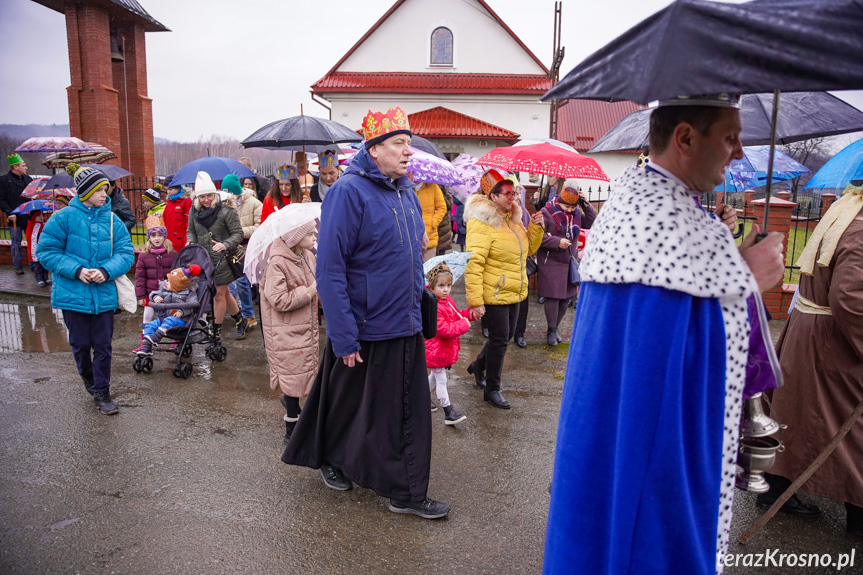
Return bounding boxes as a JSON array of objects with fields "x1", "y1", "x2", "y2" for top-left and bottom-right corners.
[{"x1": 282, "y1": 108, "x2": 449, "y2": 519}]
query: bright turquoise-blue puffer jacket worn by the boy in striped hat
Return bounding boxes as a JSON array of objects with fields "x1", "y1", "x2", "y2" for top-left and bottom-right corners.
[{"x1": 36, "y1": 196, "x2": 135, "y2": 314}]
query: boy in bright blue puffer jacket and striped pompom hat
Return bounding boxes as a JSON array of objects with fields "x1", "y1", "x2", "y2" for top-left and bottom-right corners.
[{"x1": 36, "y1": 164, "x2": 135, "y2": 415}]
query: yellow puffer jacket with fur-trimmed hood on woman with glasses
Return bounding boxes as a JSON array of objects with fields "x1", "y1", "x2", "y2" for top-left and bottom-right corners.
[{"x1": 464, "y1": 193, "x2": 543, "y2": 307}]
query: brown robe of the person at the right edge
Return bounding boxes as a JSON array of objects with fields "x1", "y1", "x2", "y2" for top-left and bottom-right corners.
[{"x1": 770, "y1": 215, "x2": 863, "y2": 507}]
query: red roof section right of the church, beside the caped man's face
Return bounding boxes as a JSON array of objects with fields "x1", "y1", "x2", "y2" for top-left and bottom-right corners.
[{"x1": 557, "y1": 100, "x2": 643, "y2": 152}]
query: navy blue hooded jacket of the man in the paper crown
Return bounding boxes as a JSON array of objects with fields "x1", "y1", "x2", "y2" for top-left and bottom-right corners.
[{"x1": 316, "y1": 149, "x2": 425, "y2": 357}]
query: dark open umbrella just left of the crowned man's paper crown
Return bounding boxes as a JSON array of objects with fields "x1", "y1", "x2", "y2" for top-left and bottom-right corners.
[{"x1": 240, "y1": 114, "x2": 363, "y2": 151}]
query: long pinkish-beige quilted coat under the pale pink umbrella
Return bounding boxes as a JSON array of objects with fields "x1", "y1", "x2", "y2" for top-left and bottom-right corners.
[{"x1": 261, "y1": 240, "x2": 318, "y2": 397}]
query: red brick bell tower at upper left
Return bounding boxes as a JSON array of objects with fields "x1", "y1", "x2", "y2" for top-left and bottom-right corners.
[{"x1": 33, "y1": 0, "x2": 170, "y2": 177}]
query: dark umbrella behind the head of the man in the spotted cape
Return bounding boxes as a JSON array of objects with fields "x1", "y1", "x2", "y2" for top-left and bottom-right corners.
[{"x1": 588, "y1": 92, "x2": 863, "y2": 153}]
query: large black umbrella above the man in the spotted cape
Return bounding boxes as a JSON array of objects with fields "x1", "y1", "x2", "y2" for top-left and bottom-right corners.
[{"x1": 542, "y1": 0, "x2": 863, "y2": 104}]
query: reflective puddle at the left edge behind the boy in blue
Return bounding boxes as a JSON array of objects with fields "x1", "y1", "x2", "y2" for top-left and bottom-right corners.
[{"x1": 0, "y1": 303, "x2": 140, "y2": 353}]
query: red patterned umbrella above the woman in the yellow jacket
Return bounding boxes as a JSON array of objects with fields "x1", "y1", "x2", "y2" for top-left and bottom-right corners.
[{"x1": 476, "y1": 143, "x2": 609, "y2": 182}]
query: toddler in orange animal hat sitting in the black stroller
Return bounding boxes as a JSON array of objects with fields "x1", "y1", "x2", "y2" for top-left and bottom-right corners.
[{"x1": 138, "y1": 264, "x2": 201, "y2": 356}]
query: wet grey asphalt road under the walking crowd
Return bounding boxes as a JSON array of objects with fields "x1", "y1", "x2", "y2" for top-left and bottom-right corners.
[{"x1": 0, "y1": 295, "x2": 863, "y2": 574}]
